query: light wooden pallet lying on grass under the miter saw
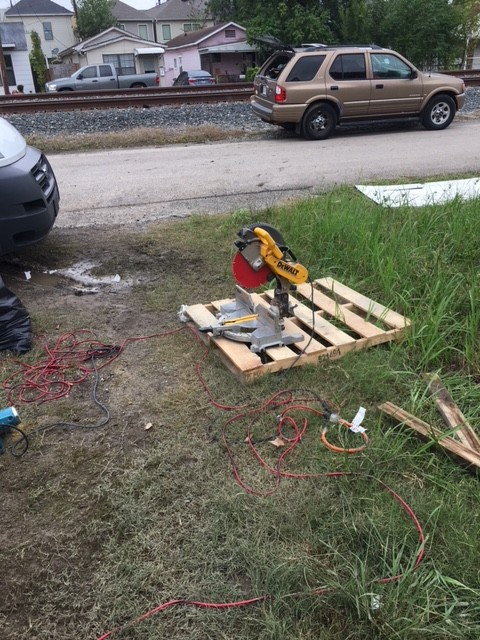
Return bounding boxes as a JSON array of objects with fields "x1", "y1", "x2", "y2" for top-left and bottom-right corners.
[{"x1": 184, "y1": 278, "x2": 410, "y2": 383}]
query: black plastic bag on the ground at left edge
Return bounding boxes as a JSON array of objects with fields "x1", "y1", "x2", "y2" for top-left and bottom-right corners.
[{"x1": 0, "y1": 276, "x2": 32, "y2": 353}]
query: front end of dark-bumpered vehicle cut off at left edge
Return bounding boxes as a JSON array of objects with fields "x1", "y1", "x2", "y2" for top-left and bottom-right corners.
[{"x1": 0, "y1": 118, "x2": 60, "y2": 255}]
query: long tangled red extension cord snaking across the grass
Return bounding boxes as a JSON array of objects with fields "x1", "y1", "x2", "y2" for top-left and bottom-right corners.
[{"x1": 2, "y1": 325, "x2": 425, "y2": 640}]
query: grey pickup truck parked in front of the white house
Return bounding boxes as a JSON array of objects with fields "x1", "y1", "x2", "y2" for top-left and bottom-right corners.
[{"x1": 45, "y1": 62, "x2": 160, "y2": 92}]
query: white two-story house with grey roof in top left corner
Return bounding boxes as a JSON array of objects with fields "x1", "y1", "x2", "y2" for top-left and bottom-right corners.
[{"x1": 4, "y1": 0, "x2": 76, "y2": 59}]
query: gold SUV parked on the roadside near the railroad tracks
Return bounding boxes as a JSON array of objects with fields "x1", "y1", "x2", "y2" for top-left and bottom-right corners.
[{"x1": 250, "y1": 44, "x2": 465, "y2": 140}]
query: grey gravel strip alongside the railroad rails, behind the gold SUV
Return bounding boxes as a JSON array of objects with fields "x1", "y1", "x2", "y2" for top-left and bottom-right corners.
[{"x1": 5, "y1": 87, "x2": 480, "y2": 136}]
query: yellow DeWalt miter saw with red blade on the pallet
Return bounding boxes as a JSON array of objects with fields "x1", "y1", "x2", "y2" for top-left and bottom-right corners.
[{"x1": 182, "y1": 223, "x2": 308, "y2": 352}]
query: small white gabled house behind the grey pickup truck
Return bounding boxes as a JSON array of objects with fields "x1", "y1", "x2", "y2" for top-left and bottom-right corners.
[{"x1": 57, "y1": 27, "x2": 165, "y2": 86}]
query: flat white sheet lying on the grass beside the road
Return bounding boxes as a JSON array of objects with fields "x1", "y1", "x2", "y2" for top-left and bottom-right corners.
[{"x1": 356, "y1": 178, "x2": 480, "y2": 207}]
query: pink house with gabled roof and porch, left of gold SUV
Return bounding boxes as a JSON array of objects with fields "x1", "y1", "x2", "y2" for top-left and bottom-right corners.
[{"x1": 164, "y1": 22, "x2": 256, "y2": 87}]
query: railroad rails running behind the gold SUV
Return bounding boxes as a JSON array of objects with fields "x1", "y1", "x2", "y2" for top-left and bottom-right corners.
[{"x1": 0, "y1": 69, "x2": 480, "y2": 115}]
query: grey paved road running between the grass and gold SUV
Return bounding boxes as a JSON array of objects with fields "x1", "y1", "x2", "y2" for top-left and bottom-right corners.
[{"x1": 50, "y1": 120, "x2": 480, "y2": 227}]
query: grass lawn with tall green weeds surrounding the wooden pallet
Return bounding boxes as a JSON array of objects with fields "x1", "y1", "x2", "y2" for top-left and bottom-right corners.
[{"x1": 0, "y1": 181, "x2": 480, "y2": 640}]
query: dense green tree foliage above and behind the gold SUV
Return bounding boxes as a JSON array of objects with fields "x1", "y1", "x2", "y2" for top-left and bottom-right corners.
[{"x1": 209, "y1": 0, "x2": 466, "y2": 69}]
